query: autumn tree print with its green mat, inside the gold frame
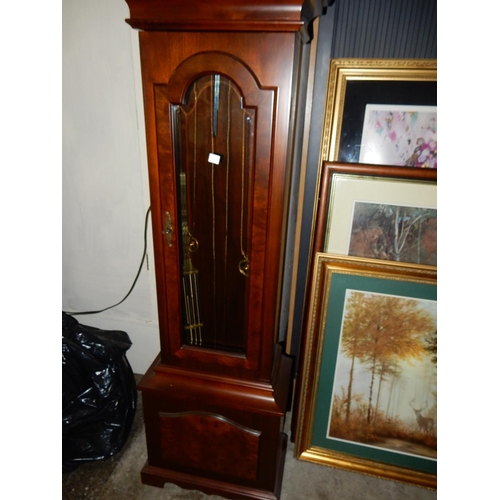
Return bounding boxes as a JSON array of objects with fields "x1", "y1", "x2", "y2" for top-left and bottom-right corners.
[{"x1": 313, "y1": 274, "x2": 437, "y2": 473}]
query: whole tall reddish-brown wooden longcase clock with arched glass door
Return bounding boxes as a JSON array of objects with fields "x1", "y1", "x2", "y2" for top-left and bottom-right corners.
[{"x1": 123, "y1": 0, "x2": 331, "y2": 499}]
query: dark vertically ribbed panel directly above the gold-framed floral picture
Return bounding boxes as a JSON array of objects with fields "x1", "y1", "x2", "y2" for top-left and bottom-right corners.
[{"x1": 330, "y1": 0, "x2": 437, "y2": 59}]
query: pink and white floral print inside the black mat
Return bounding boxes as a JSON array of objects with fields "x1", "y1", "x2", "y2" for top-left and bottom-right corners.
[{"x1": 359, "y1": 104, "x2": 437, "y2": 168}]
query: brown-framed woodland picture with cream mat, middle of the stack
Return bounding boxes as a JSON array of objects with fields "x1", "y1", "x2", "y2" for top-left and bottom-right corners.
[{"x1": 313, "y1": 162, "x2": 437, "y2": 266}]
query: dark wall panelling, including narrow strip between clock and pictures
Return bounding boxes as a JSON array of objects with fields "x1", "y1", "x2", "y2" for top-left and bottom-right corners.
[{"x1": 288, "y1": 0, "x2": 437, "y2": 364}]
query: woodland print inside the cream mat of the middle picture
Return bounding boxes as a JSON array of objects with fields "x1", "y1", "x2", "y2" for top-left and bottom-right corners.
[{"x1": 348, "y1": 201, "x2": 437, "y2": 266}]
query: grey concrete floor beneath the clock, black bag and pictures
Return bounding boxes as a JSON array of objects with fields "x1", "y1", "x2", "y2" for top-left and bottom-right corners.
[{"x1": 62, "y1": 376, "x2": 437, "y2": 500}]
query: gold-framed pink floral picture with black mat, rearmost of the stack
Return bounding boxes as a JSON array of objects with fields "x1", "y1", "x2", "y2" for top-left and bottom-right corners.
[{"x1": 321, "y1": 59, "x2": 437, "y2": 168}]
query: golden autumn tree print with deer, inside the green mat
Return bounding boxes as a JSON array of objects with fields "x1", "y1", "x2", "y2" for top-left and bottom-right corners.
[{"x1": 328, "y1": 290, "x2": 437, "y2": 458}]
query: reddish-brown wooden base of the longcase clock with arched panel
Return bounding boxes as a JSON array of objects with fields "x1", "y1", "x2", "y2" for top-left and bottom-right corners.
[{"x1": 139, "y1": 346, "x2": 292, "y2": 499}]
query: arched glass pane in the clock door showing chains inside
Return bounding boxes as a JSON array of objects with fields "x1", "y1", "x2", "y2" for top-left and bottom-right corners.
[{"x1": 175, "y1": 74, "x2": 255, "y2": 354}]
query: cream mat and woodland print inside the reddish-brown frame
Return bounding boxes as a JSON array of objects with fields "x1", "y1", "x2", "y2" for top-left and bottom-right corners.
[{"x1": 325, "y1": 174, "x2": 437, "y2": 265}]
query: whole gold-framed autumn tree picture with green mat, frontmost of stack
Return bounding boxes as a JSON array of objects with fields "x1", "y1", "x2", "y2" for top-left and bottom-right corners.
[{"x1": 294, "y1": 253, "x2": 437, "y2": 488}]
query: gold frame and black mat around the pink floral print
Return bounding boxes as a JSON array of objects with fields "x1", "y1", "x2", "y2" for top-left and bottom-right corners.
[{"x1": 320, "y1": 59, "x2": 437, "y2": 163}]
